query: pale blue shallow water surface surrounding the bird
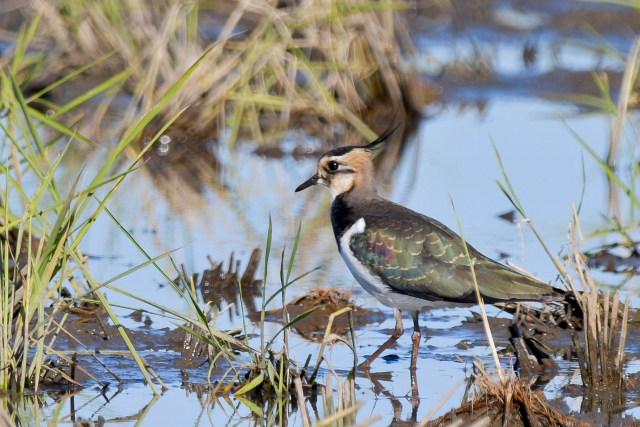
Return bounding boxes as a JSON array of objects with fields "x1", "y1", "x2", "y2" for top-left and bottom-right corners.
[{"x1": 10, "y1": 0, "x2": 638, "y2": 425}]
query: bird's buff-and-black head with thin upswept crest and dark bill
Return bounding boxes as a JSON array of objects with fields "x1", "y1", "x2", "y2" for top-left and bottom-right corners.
[{"x1": 296, "y1": 126, "x2": 397, "y2": 199}]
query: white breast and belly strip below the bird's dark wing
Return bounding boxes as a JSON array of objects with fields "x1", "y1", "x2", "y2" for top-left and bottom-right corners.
[{"x1": 340, "y1": 218, "x2": 453, "y2": 311}]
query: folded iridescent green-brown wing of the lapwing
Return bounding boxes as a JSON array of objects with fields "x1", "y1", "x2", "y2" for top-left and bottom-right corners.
[{"x1": 350, "y1": 205, "x2": 557, "y2": 302}]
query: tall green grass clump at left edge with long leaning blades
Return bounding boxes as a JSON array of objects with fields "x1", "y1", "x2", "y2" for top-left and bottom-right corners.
[{"x1": 0, "y1": 41, "x2": 232, "y2": 393}]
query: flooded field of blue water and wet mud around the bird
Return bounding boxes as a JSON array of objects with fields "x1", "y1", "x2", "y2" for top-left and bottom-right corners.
[{"x1": 0, "y1": 1, "x2": 640, "y2": 426}]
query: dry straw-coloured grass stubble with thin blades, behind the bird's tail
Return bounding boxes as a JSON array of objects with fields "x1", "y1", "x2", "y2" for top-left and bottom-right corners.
[{"x1": 496, "y1": 114, "x2": 637, "y2": 424}]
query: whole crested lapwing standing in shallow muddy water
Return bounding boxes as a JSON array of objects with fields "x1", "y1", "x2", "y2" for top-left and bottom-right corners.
[{"x1": 295, "y1": 126, "x2": 564, "y2": 392}]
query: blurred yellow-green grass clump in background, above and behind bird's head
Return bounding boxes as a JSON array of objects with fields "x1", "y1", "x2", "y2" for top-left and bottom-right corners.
[{"x1": 8, "y1": 0, "x2": 433, "y2": 142}]
